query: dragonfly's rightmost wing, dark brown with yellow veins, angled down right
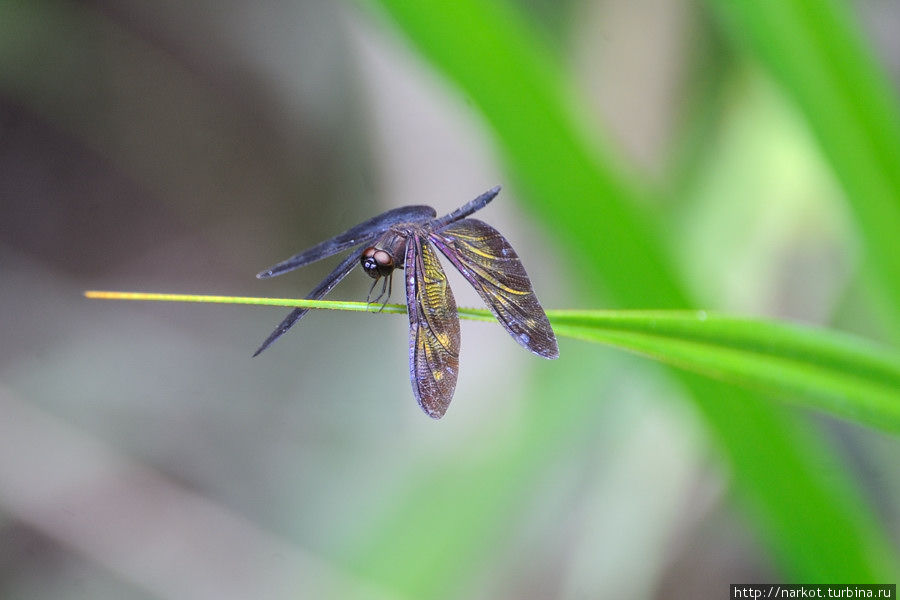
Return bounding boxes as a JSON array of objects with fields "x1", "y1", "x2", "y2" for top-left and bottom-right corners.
[{"x1": 429, "y1": 219, "x2": 559, "y2": 358}]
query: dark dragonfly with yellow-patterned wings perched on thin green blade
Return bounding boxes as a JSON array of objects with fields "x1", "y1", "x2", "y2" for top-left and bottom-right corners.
[{"x1": 253, "y1": 186, "x2": 559, "y2": 419}]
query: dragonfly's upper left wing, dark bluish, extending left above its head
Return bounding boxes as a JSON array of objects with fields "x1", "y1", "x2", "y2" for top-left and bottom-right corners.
[{"x1": 256, "y1": 205, "x2": 437, "y2": 279}]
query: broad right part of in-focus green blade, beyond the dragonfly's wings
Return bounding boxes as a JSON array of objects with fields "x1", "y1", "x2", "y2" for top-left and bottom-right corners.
[{"x1": 551, "y1": 311, "x2": 900, "y2": 433}]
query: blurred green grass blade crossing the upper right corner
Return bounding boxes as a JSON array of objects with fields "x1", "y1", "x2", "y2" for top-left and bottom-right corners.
[{"x1": 712, "y1": 0, "x2": 900, "y2": 339}]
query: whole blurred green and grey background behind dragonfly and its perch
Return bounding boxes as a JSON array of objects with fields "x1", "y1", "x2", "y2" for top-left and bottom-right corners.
[{"x1": 0, "y1": 0, "x2": 900, "y2": 599}]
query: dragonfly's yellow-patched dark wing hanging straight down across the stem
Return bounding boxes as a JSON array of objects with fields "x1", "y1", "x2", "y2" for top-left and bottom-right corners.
[{"x1": 405, "y1": 233, "x2": 459, "y2": 419}]
